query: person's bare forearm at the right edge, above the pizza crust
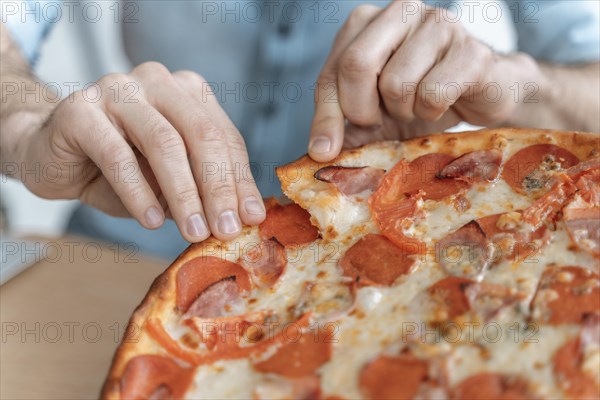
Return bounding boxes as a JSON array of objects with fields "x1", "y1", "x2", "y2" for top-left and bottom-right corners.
[{"x1": 505, "y1": 59, "x2": 600, "y2": 132}]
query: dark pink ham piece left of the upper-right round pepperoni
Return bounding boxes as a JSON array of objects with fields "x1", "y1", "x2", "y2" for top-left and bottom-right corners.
[{"x1": 438, "y1": 149, "x2": 502, "y2": 182}]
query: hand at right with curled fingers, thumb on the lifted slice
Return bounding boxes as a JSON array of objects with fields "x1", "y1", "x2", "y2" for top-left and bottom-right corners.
[{"x1": 309, "y1": 1, "x2": 537, "y2": 162}]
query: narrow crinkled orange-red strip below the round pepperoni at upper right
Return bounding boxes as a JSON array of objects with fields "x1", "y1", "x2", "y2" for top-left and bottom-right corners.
[{"x1": 523, "y1": 174, "x2": 577, "y2": 229}]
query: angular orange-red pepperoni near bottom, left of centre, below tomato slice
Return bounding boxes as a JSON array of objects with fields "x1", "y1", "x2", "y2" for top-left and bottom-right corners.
[{"x1": 254, "y1": 324, "x2": 333, "y2": 378}]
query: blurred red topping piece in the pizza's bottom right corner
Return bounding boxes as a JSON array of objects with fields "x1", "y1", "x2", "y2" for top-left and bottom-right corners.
[{"x1": 553, "y1": 314, "x2": 600, "y2": 399}]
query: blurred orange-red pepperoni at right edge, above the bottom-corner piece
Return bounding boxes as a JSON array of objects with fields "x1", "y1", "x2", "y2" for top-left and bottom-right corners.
[{"x1": 531, "y1": 267, "x2": 600, "y2": 325}]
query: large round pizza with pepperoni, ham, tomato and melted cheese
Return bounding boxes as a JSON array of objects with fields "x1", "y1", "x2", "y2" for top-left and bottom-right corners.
[{"x1": 102, "y1": 129, "x2": 600, "y2": 400}]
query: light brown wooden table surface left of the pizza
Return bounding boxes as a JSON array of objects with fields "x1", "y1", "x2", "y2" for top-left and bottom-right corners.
[{"x1": 0, "y1": 237, "x2": 168, "y2": 399}]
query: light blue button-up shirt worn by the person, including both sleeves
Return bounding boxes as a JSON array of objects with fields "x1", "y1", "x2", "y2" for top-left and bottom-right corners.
[{"x1": 2, "y1": 0, "x2": 600, "y2": 258}]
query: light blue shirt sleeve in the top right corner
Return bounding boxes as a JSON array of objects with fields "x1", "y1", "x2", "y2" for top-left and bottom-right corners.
[{"x1": 508, "y1": 0, "x2": 600, "y2": 64}]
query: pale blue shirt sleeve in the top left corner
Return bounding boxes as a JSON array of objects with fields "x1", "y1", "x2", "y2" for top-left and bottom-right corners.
[{"x1": 1, "y1": 0, "x2": 56, "y2": 65}]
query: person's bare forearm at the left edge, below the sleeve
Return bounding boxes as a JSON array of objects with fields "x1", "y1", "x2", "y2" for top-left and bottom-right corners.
[{"x1": 0, "y1": 23, "x2": 54, "y2": 172}]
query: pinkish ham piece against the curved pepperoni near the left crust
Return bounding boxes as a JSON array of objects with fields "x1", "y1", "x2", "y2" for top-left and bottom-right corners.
[{"x1": 183, "y1": 278, "x2": 245, "y2": 319}]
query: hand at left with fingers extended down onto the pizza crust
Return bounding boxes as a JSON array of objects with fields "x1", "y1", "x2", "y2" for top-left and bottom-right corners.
[{"x1": 20, "y1": 62, "x2": 265, "y2": 242}]
